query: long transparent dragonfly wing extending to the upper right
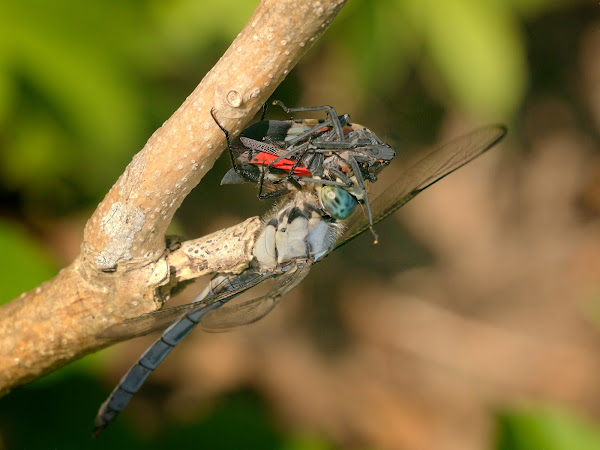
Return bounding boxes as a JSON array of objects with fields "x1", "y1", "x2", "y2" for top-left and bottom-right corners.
[{"x1": 335, "y1": 125, "x2": 507, "y2": 248}]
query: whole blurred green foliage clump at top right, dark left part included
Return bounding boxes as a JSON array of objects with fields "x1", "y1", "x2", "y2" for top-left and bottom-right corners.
[{"x1": 330, "y1": 0, "x2": 527, "y2": 115}]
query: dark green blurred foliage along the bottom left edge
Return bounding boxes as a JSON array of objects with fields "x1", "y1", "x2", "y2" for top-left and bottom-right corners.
[{"x1": 0, "y1": 372, "x2": 298, "y2": 450}]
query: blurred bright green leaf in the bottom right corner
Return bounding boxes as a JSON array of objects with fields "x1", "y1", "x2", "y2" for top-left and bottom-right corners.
[{"x1": 496, "y1": 408, "x2": 600, "y2": 450}]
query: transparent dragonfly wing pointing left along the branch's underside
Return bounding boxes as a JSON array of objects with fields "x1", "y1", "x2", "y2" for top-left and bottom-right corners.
[{"x1": 101, "y1": 272, "x2": 276, "y2": 340}]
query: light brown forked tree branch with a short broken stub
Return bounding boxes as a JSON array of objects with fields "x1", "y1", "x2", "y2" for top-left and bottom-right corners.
[{"x1": 0, "y1": 0, "x2": 345, "y2": 394}]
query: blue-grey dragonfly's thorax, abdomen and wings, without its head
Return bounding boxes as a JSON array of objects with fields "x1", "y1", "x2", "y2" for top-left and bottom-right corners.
[{"x1": 94, "y1": 125, "x2": 507, "y2": 435}]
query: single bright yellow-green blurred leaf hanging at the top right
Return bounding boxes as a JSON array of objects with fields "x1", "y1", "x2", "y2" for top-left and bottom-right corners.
[{"x1": 406, "y1": 0, "x2": 527, "y2": 114}]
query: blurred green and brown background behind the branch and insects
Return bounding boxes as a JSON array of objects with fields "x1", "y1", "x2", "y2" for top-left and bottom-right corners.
[{"x1": 0, "y1": 0, "x2": 600, "y2": 450}]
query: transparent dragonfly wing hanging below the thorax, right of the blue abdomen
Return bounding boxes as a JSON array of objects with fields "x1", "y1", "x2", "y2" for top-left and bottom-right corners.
[{"x1": 200, "y1": 263, "x2": 311, "y2": 331}]
